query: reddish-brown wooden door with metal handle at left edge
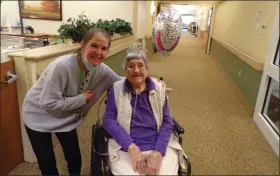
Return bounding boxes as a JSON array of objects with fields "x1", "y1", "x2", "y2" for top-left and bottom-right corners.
[{"x1": 0, "y1": 59, "x2": 23, "y2": 176}]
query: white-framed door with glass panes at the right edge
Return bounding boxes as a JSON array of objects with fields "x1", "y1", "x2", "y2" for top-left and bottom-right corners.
[{"x1": 253, "y1": 18, "x2": 280, "y2": 157}]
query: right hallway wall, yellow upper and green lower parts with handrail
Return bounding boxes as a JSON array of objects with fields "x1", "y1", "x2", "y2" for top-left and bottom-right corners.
[{"x1": 210, "y1": 1, "x2": 279, "y2": 109}]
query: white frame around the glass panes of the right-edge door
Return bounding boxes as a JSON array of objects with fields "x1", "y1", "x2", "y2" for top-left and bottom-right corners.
[{"x1": 253, "y1": 8, "x2": 279, "y2": 157}]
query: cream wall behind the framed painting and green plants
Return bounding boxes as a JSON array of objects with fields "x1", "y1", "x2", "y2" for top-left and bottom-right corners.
[{"x1": 1, "y1": 1, "x2": 136, "y2": 34}]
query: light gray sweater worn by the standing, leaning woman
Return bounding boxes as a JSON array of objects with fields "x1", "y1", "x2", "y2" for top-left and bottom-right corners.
[{"x1": 22, "y1": 54, "x2": 122, "y2": 132}]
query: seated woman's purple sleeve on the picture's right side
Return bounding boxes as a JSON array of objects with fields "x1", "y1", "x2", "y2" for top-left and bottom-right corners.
[{"x1": 154, "y1": 96, "x2": 174, "y2": 156}]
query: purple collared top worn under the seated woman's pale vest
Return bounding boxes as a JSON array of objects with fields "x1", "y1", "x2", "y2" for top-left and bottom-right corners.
[{"x1": 103, "y1": 77, "x2": 173, "y2": 155}]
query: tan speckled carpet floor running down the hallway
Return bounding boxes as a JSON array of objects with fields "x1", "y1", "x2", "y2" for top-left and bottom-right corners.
[{"x1": 10, "y1": 33, "x2": 279, "y2": 175}]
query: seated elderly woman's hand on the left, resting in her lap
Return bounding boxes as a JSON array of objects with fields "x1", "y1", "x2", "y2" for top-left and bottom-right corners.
[{"x1": 128, "y1": 143, "x2": 147, "y2": 174}]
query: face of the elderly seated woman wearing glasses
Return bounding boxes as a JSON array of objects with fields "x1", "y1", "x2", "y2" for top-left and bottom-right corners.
[{"x1": 125, "y1": 58, "x2": 148, "y2": 86}]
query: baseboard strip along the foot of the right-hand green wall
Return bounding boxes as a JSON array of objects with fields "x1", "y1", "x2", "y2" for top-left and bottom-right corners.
[{"x1": 211, "y1": 57, "x2": 254, "y2": 117}]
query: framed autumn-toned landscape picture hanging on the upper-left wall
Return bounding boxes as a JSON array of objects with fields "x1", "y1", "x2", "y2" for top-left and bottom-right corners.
[{"x1": 18, "y1": 0, "x2": 62, "y2": 21}]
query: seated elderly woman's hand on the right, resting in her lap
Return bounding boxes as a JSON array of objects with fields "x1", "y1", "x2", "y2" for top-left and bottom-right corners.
[{"x1": 146, "y1": 150, "x2": 163, "y2": 175}]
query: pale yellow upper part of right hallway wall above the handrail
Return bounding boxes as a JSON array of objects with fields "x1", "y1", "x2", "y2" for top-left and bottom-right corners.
[{"x1": 212, "y1": 1, "x2": 279, "y2": 62}]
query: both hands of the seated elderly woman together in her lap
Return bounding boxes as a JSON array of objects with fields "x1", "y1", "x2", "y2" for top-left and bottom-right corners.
[{"x1": 128, "y1": 143, "x2": 163, "y2": 175}]
